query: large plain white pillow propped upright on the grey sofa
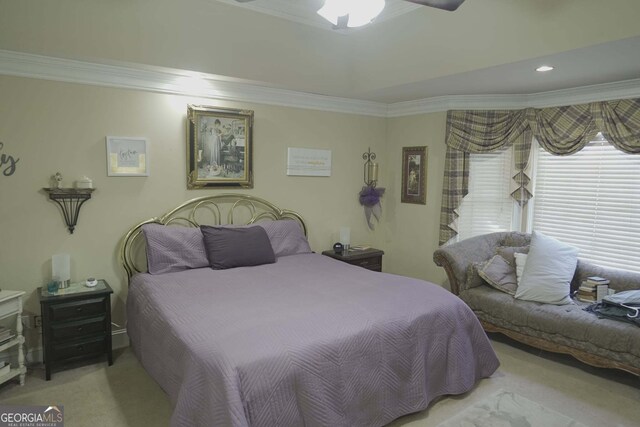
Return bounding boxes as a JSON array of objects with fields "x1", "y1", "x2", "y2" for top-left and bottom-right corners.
[{"x1": 515, "y1": 231, "x2": 578, "y2": 305}]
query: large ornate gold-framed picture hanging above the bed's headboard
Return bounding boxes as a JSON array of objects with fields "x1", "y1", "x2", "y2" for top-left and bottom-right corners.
[{"x1": 187, "y1": 105, "x2": 253, "y2": 189}]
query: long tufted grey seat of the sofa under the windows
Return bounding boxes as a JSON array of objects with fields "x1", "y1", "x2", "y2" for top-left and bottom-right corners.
[{"x1": 460, "y1": 286, "x2": 640, "y2": 366}]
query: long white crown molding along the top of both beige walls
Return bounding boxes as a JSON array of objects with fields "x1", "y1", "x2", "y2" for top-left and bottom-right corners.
[{"x1": 0, "y1": 50, "x2": 640, "y2": 117}]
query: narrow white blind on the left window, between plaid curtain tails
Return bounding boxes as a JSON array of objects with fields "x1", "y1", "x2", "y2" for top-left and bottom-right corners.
[{"x1": 457, "y1": 147, "x2": 515, "y2": 240}]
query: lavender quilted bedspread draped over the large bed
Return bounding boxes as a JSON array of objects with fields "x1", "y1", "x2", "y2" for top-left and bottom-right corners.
[{"x1": 127, "y1": 254, "x2": 499, "y2": 427}]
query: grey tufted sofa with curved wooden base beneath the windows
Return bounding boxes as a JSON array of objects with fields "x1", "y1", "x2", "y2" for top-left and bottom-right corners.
[{"x1": 433, "y1": 232, "x2": 640, "y2": 376}]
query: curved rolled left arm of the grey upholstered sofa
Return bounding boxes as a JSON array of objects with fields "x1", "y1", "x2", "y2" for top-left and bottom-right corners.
[{"x1": 433, "y1": 232, "x2": 526, "y2": 295}]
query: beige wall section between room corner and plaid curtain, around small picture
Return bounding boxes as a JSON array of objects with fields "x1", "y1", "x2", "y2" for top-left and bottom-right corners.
[{"x1": 380, "y1": 112, "x2": 446, "y2": 285}]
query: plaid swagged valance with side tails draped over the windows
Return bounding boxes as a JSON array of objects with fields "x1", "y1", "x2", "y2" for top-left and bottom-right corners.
[{"x1": 440, "y1": 98, "x2": 640, "y2": 245}]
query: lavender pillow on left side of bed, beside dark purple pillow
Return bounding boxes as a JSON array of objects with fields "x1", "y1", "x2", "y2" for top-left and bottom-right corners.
[{"x1": 142, "y1": 224, "x2": 209, "y2": 274}]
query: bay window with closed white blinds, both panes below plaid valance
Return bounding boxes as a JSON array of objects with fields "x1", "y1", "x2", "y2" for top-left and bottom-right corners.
[{"x1": 457, "y1": 135, "x2": 640, "y2": 272}]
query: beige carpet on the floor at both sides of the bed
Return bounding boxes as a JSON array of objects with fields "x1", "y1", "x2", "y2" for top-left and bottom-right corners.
[{"x1": 0, "y1": 336, "x2": 640, "y2": 427}]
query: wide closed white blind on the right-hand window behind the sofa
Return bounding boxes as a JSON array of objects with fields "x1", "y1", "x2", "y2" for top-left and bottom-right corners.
[{"x1": 533, "y1": 137, "x2": 640, "y2": 272}]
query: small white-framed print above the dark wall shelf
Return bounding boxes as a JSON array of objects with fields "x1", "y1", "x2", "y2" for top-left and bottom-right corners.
[{"x1": 107, "y1": 136, "x2": 149, "y2": 176}]
